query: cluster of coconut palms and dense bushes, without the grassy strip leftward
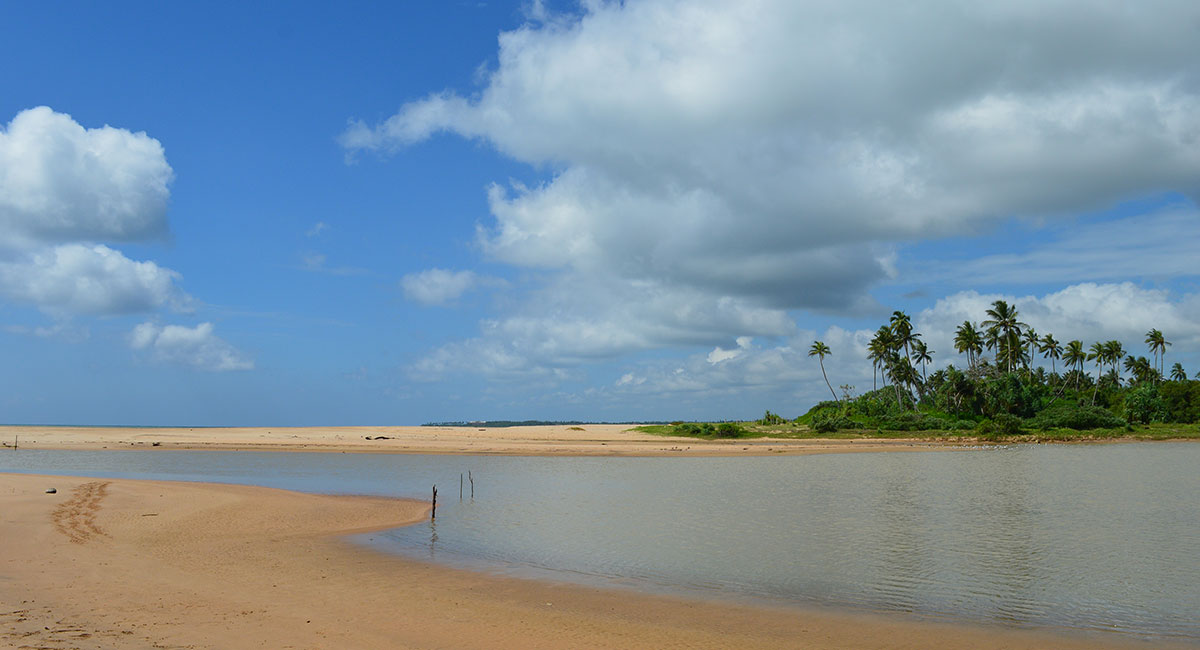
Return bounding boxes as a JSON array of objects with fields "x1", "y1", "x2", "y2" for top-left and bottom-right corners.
[{"x1": 809, "y1": 300, "x2": 1200, "y2": 429}]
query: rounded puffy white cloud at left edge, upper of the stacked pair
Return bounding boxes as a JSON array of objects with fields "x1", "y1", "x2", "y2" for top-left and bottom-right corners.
[{"x1": 0, "y1": 107, "x2": 173, "y2": 247}]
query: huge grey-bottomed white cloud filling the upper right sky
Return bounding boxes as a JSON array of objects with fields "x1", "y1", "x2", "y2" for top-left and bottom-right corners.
[{"x1": 342, "y1": 0, "x2": 1200, "y2": 381}]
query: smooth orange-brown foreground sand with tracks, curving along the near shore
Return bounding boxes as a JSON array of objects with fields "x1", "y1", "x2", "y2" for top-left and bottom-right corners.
[{"x1": 0, "y1": 474, "x2": 1185, "y2": 650}]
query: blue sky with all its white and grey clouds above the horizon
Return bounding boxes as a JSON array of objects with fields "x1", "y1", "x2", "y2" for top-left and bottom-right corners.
[{"x1": 0, "y1": 0, "x2": 1200, "y2": 426}]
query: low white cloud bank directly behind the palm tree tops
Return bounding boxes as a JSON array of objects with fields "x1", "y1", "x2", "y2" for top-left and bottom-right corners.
[{"x1": 604, "y1": 283, "x2": 1200, "y2": 416}]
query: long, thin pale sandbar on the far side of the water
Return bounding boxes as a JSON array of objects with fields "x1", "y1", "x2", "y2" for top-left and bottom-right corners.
[{"x1": 0, "y1": 425, "x2": 961, "y2": 456}]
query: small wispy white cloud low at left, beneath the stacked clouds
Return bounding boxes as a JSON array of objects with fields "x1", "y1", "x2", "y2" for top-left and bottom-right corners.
[{"x1": 130, "y1": 323, "x2": 254, "y2": 371}]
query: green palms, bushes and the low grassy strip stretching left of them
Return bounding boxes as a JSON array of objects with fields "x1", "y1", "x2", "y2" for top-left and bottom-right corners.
[{"x1": 638, "y1": 300, "x2": 1200, "y2": 441}]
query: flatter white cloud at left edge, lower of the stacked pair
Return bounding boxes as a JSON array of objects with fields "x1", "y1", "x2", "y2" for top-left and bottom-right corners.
[{"x1": 0, "y1": 243, "x2": 191, "y2": 317}]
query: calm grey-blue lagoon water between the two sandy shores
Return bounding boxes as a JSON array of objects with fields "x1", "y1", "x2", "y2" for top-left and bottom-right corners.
[{"x1": 0, "y1": 443, "x2": 1200, "y2": 640}]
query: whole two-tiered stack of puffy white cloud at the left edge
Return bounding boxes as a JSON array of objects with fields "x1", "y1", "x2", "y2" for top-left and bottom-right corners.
[{"x1": 0, "y1": 107, "x2": 191, "y2": 318}]
